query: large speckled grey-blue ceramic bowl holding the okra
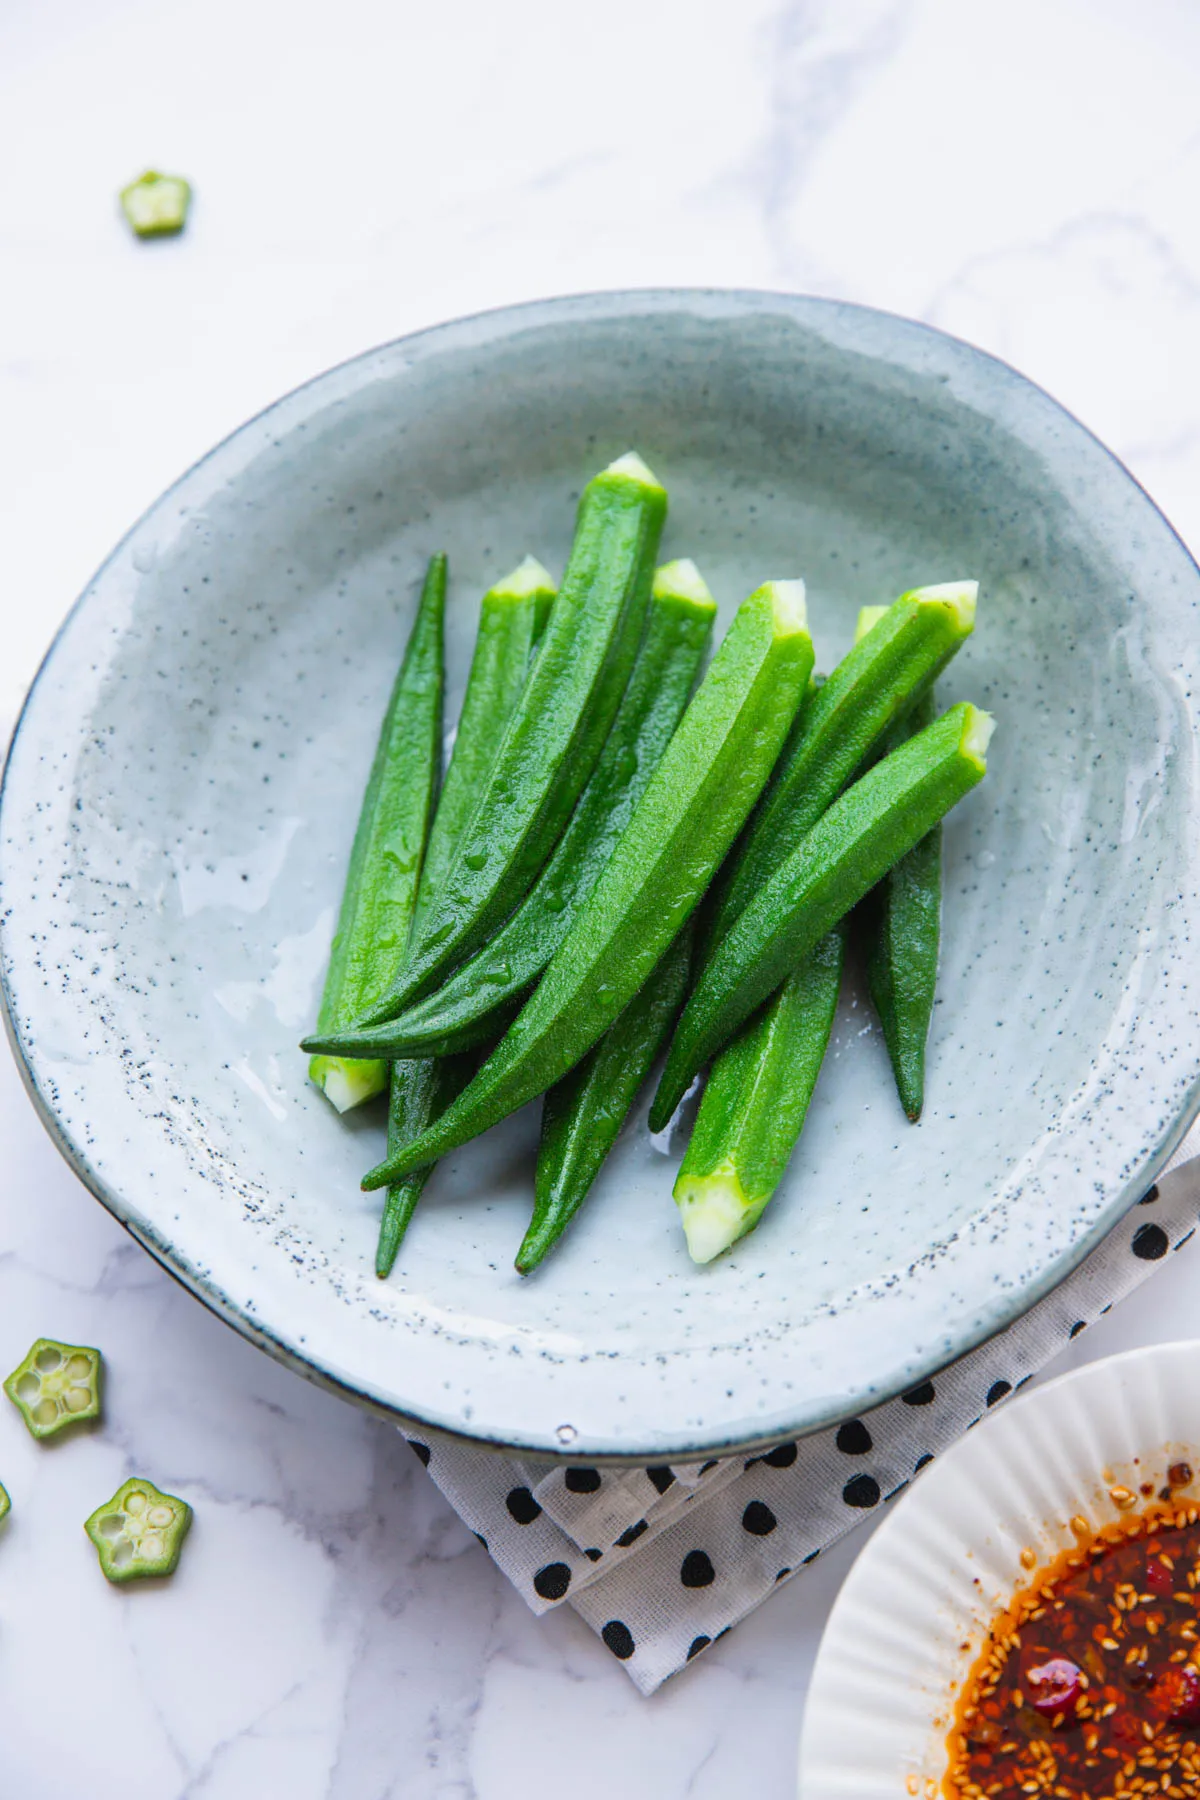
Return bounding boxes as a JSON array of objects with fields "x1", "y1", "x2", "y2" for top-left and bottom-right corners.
[{"x1": 0, "y1": 293, "x2": 1200, "y2": 1460}]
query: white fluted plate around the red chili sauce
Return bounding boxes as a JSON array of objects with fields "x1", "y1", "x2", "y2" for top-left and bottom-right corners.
[{"x1": 799, "y1": 1341, "x2": 1200, "y2": 1800}]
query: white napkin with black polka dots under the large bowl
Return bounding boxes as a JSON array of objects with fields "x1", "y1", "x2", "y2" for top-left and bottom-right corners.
[{"x1": 408, "y1": 1132, "x2": 1200, "y2": 1694}]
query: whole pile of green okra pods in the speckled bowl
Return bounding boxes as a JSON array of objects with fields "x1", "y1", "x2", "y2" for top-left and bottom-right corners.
[{"x1": 302, "y1": 454, "x2": 991, "y2": 1276}]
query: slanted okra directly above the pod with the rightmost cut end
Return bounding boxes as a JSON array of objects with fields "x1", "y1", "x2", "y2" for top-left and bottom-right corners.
[{"x1": 705, "y1": 581, "x2": 979, "y2": 945}]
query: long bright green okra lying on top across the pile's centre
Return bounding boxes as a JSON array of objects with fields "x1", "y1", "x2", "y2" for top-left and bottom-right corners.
[{"x1": 363, "y1": 581, "x2": 813, "y2": 1188}]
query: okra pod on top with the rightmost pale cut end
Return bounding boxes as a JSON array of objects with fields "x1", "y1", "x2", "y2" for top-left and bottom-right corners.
[{"x1": 649, "y1": 704, "x2": 993, "y2": 1130}]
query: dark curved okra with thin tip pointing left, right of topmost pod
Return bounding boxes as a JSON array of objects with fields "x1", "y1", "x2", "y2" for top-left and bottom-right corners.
[{"x1": 306, "y1": 560, "x2": 716, "y2": 1057}]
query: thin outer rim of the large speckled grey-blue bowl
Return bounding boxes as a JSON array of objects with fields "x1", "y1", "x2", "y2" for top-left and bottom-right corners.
[{"x1": 0, "y1": 286, "x2": 1200, "y2": 1465}]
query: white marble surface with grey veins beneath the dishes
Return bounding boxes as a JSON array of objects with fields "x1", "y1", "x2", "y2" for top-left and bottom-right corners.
[{"x1": 0, "y1": 0, "x2": 1200, "y2": 1800}]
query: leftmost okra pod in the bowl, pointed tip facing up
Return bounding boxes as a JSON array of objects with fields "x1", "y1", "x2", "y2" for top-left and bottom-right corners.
[{"x1": 308, "y1": 554, "x2": 446, "y2": 1112}]
